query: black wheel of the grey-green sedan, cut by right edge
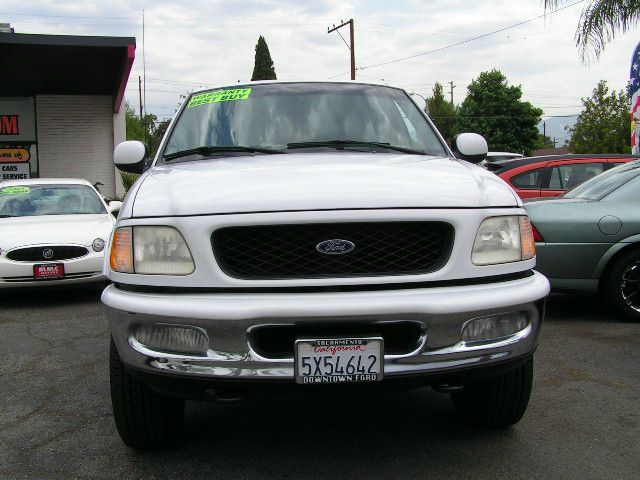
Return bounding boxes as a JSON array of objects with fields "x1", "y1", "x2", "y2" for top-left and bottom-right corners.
[{"x1": 602, "y1": 249, "x2": 640, "y2": 322}]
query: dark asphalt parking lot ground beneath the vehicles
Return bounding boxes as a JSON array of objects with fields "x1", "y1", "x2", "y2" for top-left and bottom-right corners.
[{"x1": 0, "y1": 290, "x2": 640, "y2": 480}]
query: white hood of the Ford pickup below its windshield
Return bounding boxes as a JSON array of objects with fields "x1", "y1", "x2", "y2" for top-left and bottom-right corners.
[{"x1": 132, "y1": 151, "x2": 520, "y2": 217}]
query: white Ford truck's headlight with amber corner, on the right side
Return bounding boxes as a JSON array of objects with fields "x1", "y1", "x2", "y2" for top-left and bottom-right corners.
[{"x1": 471, "y1": 215, "x2": 536, "y2": 265}]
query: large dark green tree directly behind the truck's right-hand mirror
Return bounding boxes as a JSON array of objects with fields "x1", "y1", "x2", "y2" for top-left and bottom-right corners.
[{"x1": 456, "y1": 69, "x2": 542, "y2": 155}]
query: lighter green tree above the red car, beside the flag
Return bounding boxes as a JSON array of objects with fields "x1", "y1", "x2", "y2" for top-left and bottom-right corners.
[{"x1": 569, "y1": 80, "x2": 631, "y2": 153}]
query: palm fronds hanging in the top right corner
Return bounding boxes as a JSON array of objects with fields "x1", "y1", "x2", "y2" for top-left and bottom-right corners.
[{"x1": 544, "y1": 0, "x2": 640, "y2": 63}]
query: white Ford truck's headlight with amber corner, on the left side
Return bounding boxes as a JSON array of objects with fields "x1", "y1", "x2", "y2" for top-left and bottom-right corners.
[{"x1": 109, "y1": 226, "x2": 195, "y2": 275}]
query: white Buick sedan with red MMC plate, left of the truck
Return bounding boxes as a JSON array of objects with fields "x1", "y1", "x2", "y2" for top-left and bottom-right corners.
[{"x1": 0, "y1": 178, "x2": 122, "y2": 289}]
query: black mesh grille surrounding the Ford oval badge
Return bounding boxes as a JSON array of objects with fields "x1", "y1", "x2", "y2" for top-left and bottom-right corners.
[{"x1": 211, "y1": 222, "x2": 453, "y2": 279}]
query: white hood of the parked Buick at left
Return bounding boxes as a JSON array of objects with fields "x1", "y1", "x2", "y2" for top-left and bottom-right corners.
[{"x1": 0, "y1": 213, "x2": 114, "y2": 250}]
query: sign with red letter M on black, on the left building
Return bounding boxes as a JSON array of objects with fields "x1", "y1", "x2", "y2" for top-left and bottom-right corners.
[{"x1": 0, "y1": 97, "x2": 36, "y2": 143}]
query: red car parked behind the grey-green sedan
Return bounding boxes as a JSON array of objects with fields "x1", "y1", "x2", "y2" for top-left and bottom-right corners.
[{"x1": 490, "y1": 154, "x2": 639, "y2": 198}]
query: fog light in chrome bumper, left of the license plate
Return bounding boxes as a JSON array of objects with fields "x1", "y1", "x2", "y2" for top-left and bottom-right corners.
[{"x1": 134, "y1": 323, "x2": 209, "y2": 355}]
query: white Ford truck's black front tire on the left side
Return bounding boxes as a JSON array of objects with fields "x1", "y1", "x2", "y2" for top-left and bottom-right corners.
[{"x1": 109, "y1": 338, "x2": 184, "y2": 449}]
